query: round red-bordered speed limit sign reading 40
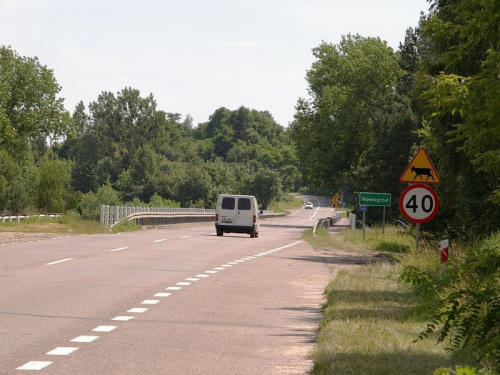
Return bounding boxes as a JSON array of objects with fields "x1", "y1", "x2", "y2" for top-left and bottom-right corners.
[{"x1": 399, "y1": 184, "x2": 439, "y2": 224}]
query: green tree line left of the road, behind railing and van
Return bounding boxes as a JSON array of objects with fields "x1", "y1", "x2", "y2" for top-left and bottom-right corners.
[{"x1": 0, "y1": 47, "x2": 301, "y2": 218}]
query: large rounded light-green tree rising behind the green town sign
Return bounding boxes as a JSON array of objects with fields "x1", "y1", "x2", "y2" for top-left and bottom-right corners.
[{"x1": 291, "y1": 35, "x2": 402, "y2": 190}]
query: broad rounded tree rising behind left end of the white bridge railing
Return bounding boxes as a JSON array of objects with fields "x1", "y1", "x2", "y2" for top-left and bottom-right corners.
[{"x1": 60, "y1": 88, "x2": 189, "y2": 194}]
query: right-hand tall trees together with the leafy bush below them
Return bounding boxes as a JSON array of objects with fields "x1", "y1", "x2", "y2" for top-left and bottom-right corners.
[{"x1": 291, "y1": 0, "x2": 500, "y2": 374}]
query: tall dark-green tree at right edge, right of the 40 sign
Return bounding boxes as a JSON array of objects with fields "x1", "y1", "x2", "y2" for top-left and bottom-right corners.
[{"x1": 416, "y1": 0, "x2": 500, "y2": 237}]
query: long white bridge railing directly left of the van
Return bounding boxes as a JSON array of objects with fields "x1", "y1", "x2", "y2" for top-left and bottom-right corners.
[{"x1": 101, "y1": 205, "x2": 215, "y2": 227}]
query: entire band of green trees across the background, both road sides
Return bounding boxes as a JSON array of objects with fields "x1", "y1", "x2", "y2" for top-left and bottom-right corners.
[{"x1": 0, "y1": 0, "x2": 500, "y2": 238}]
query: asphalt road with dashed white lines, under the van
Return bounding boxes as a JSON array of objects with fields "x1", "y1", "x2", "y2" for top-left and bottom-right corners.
[{"x1": 0, "y1": 198, "x2": 338, "y2": 375}]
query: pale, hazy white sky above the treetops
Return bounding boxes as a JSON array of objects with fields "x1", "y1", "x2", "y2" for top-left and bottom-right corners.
[{"x1": 0, "y1": 0, "x2": 429, "y2": 127}]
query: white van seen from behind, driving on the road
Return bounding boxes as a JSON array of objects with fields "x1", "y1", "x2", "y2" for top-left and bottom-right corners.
[{"x1": 215, "y1": 194, "x2": 259, "y2": 238}]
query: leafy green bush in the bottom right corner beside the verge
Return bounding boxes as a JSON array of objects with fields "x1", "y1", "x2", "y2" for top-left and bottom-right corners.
[{"x1": 402, "y1": 233, "x2": 500, "y2": 371}]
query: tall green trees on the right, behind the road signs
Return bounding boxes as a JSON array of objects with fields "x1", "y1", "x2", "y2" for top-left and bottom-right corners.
[{"x1": 291, "y1": 0, "x2": 500, "y2": 238}]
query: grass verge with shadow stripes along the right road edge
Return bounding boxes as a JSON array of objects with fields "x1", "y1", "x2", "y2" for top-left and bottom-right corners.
[{"x1": 304, "y1": 228, "x2": 469, "y2": 375}]
